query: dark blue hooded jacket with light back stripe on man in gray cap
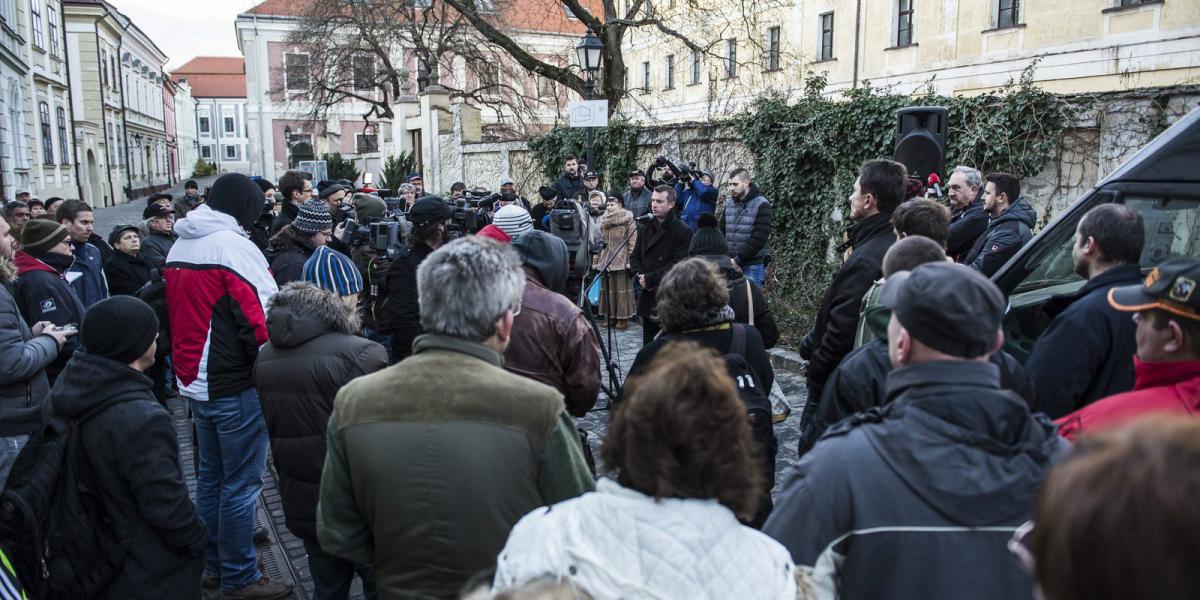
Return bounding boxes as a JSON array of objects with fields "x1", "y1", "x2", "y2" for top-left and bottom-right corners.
[{"x1": 763, "y1": 361, "x2": 1068, "y2": 600}]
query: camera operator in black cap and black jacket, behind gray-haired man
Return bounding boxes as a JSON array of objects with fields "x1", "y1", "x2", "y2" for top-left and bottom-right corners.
[{"x1": 385, "y1": 198, "x2": 452, "y2": 361}]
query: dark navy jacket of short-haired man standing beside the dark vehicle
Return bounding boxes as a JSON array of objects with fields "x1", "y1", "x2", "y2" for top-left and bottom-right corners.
[{"x1": 1025, "y1": 264, "x2": 1141, "y2": 419}]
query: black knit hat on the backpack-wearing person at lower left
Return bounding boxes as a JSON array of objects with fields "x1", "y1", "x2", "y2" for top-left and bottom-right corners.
[{"x1": 79, "y1": 295, "x2": 158, "y2": 365}]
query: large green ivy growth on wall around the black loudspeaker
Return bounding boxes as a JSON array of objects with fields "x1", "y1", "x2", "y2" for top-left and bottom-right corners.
[{"x1": 734, "y1": 76, "x2": 1079, "y2": 340}]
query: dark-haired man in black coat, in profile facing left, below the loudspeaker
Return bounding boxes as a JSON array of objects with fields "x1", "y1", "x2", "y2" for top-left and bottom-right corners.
[{"x1": 800, "y1": 160, "x2": 908, "y2": 431}]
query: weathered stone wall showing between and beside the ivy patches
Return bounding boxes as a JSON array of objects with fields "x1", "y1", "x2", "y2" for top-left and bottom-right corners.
[{"x1": 443, "y1": 85, "x2": 1200, "y2": 226}]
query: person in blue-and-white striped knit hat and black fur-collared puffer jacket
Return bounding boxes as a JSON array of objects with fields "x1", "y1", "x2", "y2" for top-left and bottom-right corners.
[{"x1": 254, "y1": 247, "x2": 388, "y2": 599}]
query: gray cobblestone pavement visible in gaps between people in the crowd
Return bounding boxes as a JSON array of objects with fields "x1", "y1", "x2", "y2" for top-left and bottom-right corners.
[{"x1": 150, "y1": 302, "x2": 806, "y2": 600}]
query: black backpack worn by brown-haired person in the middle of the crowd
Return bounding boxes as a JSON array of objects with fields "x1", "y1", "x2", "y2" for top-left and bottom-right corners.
[{"x1": 721, "y1": 323, "x2": 779, "y2": 527}]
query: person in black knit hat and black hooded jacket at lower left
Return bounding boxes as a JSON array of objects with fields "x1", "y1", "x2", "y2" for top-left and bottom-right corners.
[{"x1": 50, "y1": 296, "x2": 208, "y2": 600}]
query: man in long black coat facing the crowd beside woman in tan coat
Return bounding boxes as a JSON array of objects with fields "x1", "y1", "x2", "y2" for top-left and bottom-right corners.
[{"x1": 629, "y1": 185, "x2": 696, "y2": 344}]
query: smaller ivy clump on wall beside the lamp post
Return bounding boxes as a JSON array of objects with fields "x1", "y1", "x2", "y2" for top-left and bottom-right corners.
[{"x1": 529, "y1": 119, "x2": 637, "y2": 191}]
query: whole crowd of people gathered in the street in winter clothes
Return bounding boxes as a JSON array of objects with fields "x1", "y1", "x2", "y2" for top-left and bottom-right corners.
[{"x1": 0, "y1": 147, "x2": 1200, "y2": 600}]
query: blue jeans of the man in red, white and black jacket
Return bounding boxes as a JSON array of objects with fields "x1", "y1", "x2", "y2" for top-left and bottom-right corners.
[{"x1": 190, "y1": 388, "x2": 268, "y2": 592}]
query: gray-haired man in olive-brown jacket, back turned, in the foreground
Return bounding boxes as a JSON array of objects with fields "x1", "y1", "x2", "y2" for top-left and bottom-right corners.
[{"x1": 317, "y1": 236, "x2": 594, "y2": 598}]
